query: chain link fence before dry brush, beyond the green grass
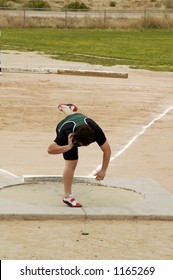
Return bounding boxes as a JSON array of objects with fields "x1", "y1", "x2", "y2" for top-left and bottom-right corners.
[{"x1": 0, "y1": 8, "x2": 173, "y2": 29}]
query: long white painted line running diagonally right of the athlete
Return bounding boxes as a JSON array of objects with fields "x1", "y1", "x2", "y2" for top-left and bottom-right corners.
[{"x1": 89, "y1": 106, "x2": 173, "y2": 176}]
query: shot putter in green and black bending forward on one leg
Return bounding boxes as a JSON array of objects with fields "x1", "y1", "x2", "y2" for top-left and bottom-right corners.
[{"x1": 48, "y1": 104, "x2": 111, "y2": 207}]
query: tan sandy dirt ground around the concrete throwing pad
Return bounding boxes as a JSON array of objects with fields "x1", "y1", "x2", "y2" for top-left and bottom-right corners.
[{"x1": 0, "y1": 51, "x2": 173, "y2": 259}]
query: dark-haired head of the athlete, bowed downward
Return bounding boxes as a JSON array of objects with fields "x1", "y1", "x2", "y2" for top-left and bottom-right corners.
[{"x1": 73, "y1": 124, "x2": 95, "y2": 146}]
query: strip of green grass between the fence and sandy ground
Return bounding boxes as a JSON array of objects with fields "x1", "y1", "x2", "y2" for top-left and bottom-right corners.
[{"x1": 0, "y1": 28, "x2": 173, "y2": 71}]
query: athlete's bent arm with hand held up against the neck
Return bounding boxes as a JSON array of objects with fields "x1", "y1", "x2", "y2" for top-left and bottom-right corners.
[{"x1": 47, "y1": 133, "x2": 73, "y2": 155}]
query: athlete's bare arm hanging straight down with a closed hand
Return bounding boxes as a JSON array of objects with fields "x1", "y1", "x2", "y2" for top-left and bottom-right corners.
[{"x1": 95, "y1": 140, "x2": 111, "y2": 181}]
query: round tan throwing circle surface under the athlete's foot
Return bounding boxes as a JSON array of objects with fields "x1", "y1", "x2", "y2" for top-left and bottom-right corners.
[{"x1": 0, "y1": 181, "x2": 143, "y2": 207}]
